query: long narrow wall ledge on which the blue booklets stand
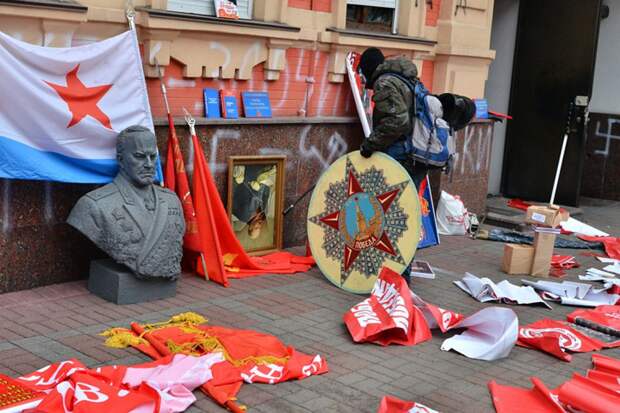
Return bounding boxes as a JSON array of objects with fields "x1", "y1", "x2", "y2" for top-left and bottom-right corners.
[{"x1": 153, "y1": 116, "x2": 359, "y2": 126}]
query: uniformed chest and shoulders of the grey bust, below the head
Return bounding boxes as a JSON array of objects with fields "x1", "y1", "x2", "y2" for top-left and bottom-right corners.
[{"x1": 67, "y1": 171, "x2": 185, "y2": 279}]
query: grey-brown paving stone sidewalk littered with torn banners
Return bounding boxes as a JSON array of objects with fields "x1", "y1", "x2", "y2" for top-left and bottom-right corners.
[{"x1": 0, "y1": 201, "x2": 620, "y2": 413}]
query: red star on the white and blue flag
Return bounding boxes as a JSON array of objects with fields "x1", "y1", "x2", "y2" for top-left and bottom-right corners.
[{"x1": 45, "y1": 65, "x2": 112, "y2": 129}]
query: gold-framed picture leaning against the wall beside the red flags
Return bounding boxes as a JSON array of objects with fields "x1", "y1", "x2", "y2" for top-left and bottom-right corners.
[{"x1": 226, "y1": 155, "x2": 286, "y2": 255}]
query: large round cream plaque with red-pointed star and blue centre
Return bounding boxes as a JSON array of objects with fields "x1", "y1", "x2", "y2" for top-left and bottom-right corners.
[{"x1": 308, "y1": 151, "x2": 420, "y2": 294}]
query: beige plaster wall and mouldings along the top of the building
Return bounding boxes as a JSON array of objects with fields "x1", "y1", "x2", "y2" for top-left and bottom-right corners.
[{"x1": 0, "y1": 0, "x2": 494, "y2": 97}]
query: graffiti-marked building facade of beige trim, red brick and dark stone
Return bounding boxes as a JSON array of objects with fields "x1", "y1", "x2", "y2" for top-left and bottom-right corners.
[{"x1": 0, "y1": 0, "x2": 495, "y2": 292}]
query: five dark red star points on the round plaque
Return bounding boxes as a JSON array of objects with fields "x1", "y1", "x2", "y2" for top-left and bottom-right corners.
[{"x1": 320, "y1": 167, "x2": 400, "y2": 271}]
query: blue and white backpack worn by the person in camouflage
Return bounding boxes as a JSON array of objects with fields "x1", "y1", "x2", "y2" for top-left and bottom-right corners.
[{"x1": 384, "y1": 72, "x2": 456, "y2": 168}]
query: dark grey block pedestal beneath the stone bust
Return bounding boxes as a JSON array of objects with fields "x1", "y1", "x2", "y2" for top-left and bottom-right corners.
[{"x1": 88, "y1": 258, "x2": 177, "y2": 304}]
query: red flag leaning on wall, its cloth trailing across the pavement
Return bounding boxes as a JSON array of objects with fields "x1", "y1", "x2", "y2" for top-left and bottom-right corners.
[{"x1": 192, "y1": 130, "x2": 314, "y2": 286}]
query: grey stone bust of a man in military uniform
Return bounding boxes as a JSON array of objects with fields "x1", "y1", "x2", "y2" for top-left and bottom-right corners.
[{"x1": 67, "y1": 126, "x2": 185, "y2": 280}]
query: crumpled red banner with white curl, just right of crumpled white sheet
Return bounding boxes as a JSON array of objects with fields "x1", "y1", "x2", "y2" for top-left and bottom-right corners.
[{"x1": 517, "y1": 319, "x2": 620, "y2": 361}]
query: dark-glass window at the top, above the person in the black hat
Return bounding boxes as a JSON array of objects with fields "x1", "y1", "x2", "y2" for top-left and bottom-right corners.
[{"x1": 347, "y1": 0, "x2": 398, "y2": 33}]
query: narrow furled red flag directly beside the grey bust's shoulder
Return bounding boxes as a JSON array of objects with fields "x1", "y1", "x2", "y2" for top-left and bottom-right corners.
[{"x1": 164, "y1": 113, "x2": 202, "y2": 252}]
